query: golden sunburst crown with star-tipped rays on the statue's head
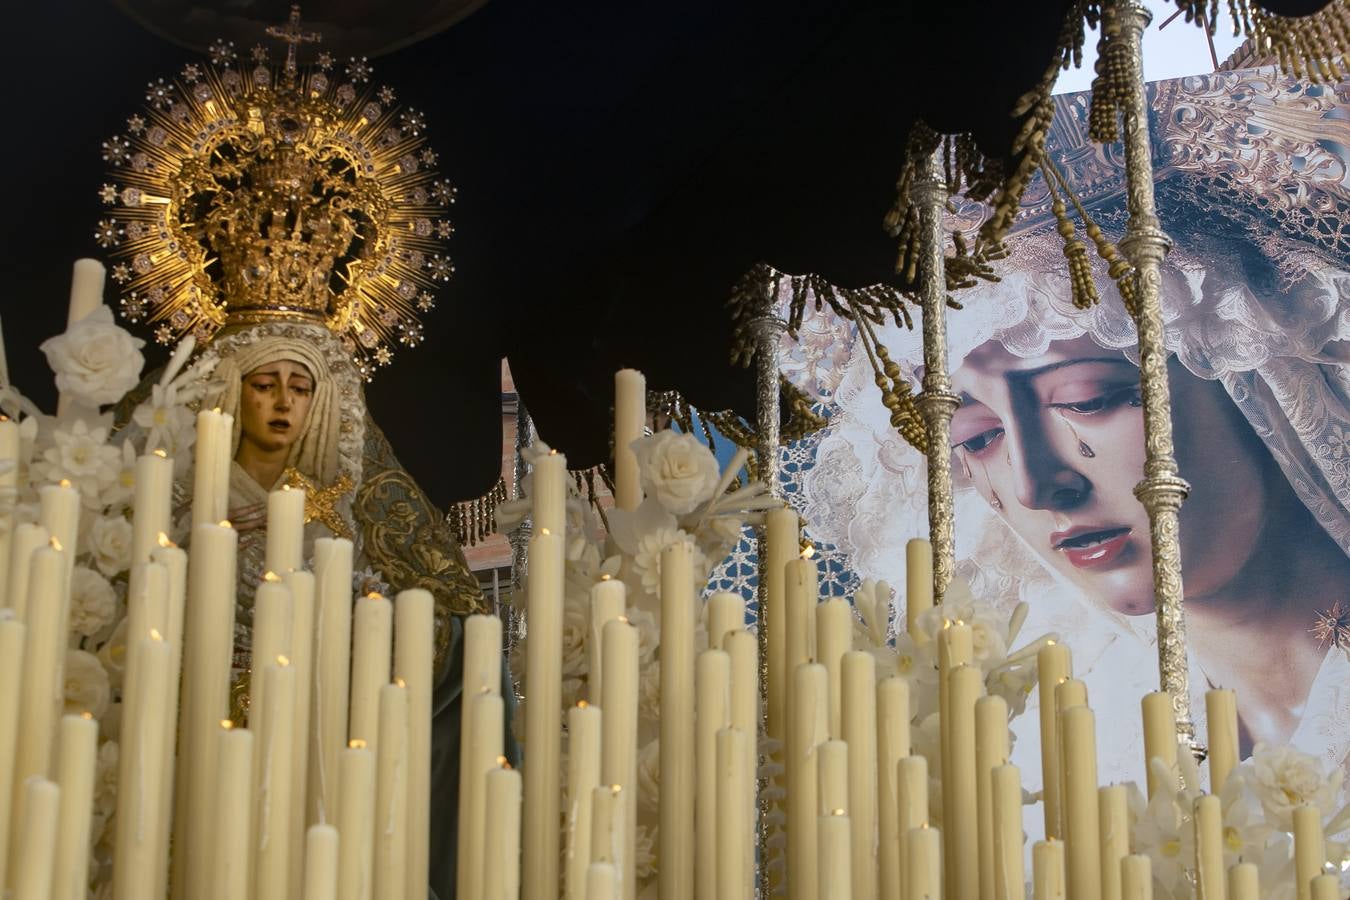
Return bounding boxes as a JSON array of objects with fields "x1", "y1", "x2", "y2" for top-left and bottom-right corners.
[{"x1": 95, "y1": 8, "x2": 455, "y2": 376}]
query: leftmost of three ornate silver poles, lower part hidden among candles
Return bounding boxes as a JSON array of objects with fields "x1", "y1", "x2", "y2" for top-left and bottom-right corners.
[{"x1": 749, "y1": 286, "x2": 787, "y2": 900}]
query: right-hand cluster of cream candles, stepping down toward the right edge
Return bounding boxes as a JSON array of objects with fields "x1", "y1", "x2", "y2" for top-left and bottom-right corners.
[{"x1": 459, "y1": 372, "x2": 1338, "y2": 900}]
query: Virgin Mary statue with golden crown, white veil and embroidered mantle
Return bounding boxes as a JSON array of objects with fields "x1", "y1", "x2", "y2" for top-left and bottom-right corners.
[{"x1": 99, "y1": 33, "x2": 510, "y2": 900}]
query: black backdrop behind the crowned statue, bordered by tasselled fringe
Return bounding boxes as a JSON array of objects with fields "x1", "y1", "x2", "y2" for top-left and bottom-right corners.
[{"x1": 0, "y1": 0, "x2": 1322, "y2": 507}]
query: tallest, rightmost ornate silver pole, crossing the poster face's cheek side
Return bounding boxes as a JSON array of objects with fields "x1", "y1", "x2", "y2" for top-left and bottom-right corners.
[{"x1": 1103, "y1": 0, "x2": 1203, "y2": 753}]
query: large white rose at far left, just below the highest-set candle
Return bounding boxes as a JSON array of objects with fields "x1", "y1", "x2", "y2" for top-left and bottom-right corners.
[{"x1": 42, "y1": 306, "x2": 146, "y2": 406}]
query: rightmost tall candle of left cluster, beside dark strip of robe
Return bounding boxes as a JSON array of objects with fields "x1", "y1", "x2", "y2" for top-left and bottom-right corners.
[{"x1": 394, "y1": 588, "x2": 432, "y2": 900}]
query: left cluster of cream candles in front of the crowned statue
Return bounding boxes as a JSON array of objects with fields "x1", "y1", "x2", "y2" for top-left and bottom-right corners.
[{"x1": 0, "y1": 410, "x2": 435, "y2": 900}]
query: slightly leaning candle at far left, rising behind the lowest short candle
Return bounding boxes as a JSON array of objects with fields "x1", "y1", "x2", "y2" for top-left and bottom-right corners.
[{"x1": 9, "y1": 546, "x2": 69, "y2": 860}]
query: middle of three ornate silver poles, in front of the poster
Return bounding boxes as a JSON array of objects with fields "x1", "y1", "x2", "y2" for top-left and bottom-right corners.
[{"x1": 914, "y1": 147, "x2": 960, "y2": 603}]
